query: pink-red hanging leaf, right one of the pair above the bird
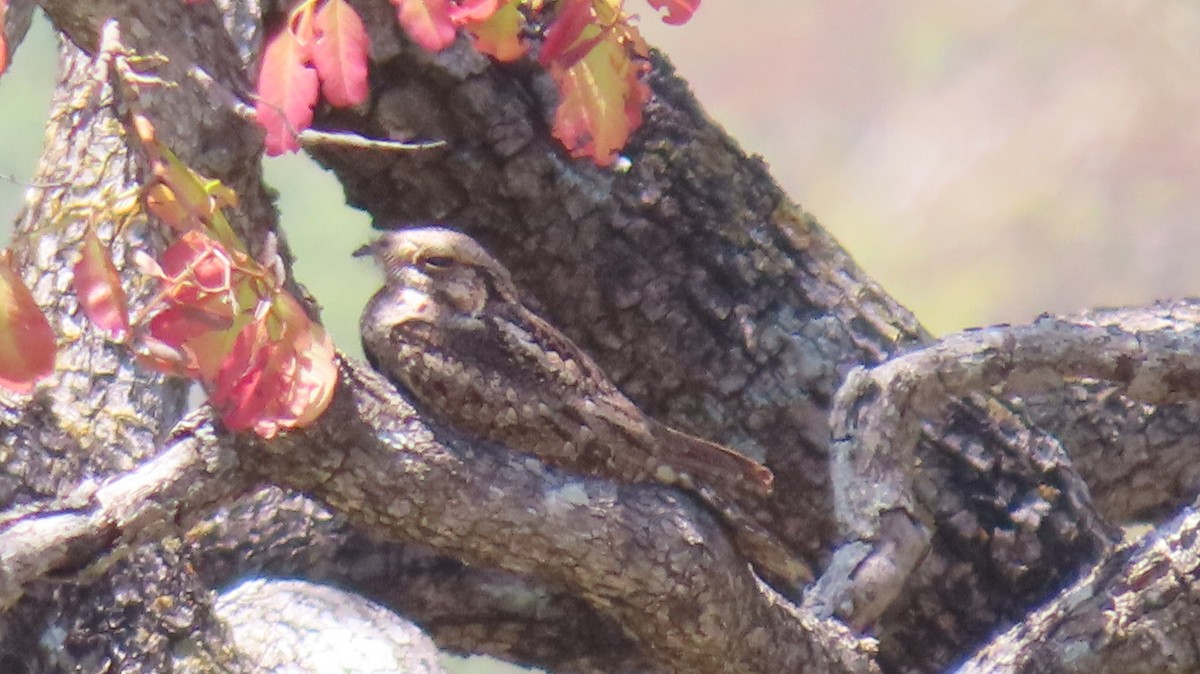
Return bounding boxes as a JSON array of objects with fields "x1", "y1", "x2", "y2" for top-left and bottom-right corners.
[{"x1": 312, "y1": 0, "x2": 370, "y2": 108}]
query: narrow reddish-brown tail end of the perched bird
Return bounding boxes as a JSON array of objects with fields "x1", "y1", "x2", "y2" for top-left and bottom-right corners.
[{"x1": 655, "y1": 426, "x2": 775, "y2": 497}]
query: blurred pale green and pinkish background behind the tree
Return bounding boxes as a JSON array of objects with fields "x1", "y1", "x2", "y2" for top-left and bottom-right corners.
[{"x1": 0, "y1": 0, "x2": 1200, "y2": 672}]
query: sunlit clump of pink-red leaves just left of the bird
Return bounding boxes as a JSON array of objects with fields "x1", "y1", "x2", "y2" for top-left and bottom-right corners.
[{"x1": 138, "y1": 230, "x2": 337, "y2": 438}]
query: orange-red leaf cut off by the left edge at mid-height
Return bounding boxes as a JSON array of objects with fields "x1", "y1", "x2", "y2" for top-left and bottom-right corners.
[{"x1": 0, "y1": 251, "x2": 55, "y2": 393}]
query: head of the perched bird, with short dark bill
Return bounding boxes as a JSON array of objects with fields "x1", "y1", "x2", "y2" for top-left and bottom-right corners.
[{"x1": 354, "y1": 227, "x2": 515, "y2": 315}]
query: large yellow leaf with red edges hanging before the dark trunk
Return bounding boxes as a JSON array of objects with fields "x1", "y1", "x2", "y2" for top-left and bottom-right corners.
[{"x1": 550, "y1": 26, "x2": 649, "y2": 166}]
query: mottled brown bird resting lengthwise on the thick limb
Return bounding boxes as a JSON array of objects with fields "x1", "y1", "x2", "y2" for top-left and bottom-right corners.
[{"x1": 355, "y1": 228, "x2": 772, "y2": 497}]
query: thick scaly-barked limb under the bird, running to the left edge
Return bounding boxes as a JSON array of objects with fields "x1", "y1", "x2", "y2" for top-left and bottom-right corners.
[{"x1": 5, "y1": 361, "x2": 872, "y2": 672}]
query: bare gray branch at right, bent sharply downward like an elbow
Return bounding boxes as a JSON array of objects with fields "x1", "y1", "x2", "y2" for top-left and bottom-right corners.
[{"x1": 821, "y1": 301, "x2": 1200, "y2": 625}]
